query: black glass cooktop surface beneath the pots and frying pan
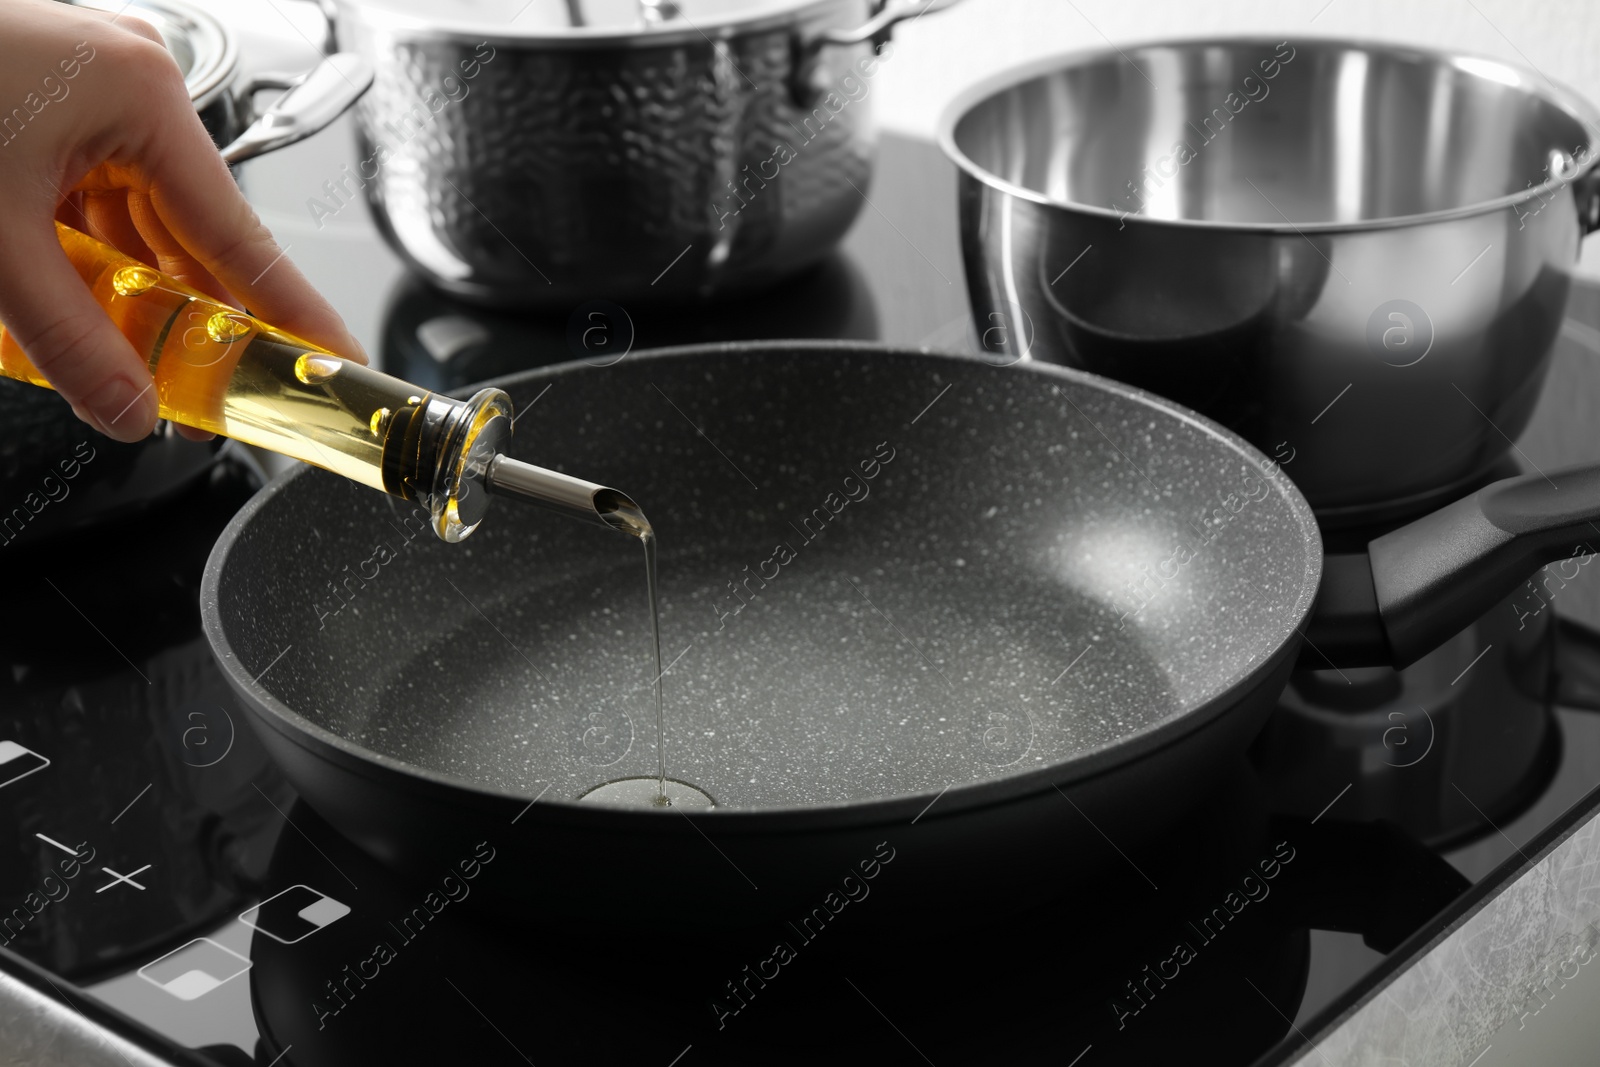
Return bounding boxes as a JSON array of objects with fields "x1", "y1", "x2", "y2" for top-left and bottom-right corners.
[{"x1": 0, "y1": 60, "x2": 1600, "y2": 1067}]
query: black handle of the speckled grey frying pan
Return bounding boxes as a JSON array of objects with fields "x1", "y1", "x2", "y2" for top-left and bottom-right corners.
[{"x1": 1302, "y1": 467, "x2": 1600, "y2": 667}]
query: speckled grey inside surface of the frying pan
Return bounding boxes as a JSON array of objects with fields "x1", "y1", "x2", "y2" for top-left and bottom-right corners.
[{"x1": 205, "y1": 346, "x2": 1322, "y2": 817}]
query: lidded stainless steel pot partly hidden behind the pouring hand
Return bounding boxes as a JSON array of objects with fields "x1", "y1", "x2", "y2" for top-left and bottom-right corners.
[{"x1": 0, "y1": 0, "x2": 371, "y2": 547}]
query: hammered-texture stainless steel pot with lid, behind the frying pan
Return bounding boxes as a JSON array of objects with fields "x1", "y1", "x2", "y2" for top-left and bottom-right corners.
[{"x1": 304, "y1": 0, "x2": 954, "y2": 306}]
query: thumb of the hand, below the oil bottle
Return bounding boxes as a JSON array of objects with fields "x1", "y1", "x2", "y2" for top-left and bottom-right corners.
[{"x1": 0, "y1": 218, "x2": 158, "y2": 442}]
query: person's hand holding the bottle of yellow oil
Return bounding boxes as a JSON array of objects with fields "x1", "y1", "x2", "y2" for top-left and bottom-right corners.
[{"x1": 0, "y1": 0, "x2": 365, "y2": 442}]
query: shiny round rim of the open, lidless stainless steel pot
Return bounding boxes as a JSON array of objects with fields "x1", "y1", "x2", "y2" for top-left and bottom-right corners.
[{"x1": 934, "y1": 34, "x2": 1600, "y2": 237}]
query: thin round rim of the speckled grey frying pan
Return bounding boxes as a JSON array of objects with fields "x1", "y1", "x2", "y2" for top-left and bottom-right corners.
[{"x1": 200, "y1": 341, "x2": 1323, "y2": 833}]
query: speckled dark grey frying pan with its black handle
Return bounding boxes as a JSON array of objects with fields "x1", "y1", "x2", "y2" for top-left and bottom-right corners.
[{"x1": 202, "y1": 342, "x2": 1600, "y2": 928}]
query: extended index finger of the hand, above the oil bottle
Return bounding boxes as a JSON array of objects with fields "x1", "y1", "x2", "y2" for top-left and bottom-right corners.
[{"x1": 133, "y1": 115, "x2": 366, "y2": 362}]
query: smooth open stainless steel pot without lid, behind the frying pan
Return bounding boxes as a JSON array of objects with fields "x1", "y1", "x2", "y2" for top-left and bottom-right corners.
[{"x1": 941, "y1": 40, "x2": 1600, "y2": 528}]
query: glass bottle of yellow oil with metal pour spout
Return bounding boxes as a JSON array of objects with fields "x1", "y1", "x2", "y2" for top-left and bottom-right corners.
[{"x1": 0, "y1": 222, "x2": 636, "y2": 541}]
